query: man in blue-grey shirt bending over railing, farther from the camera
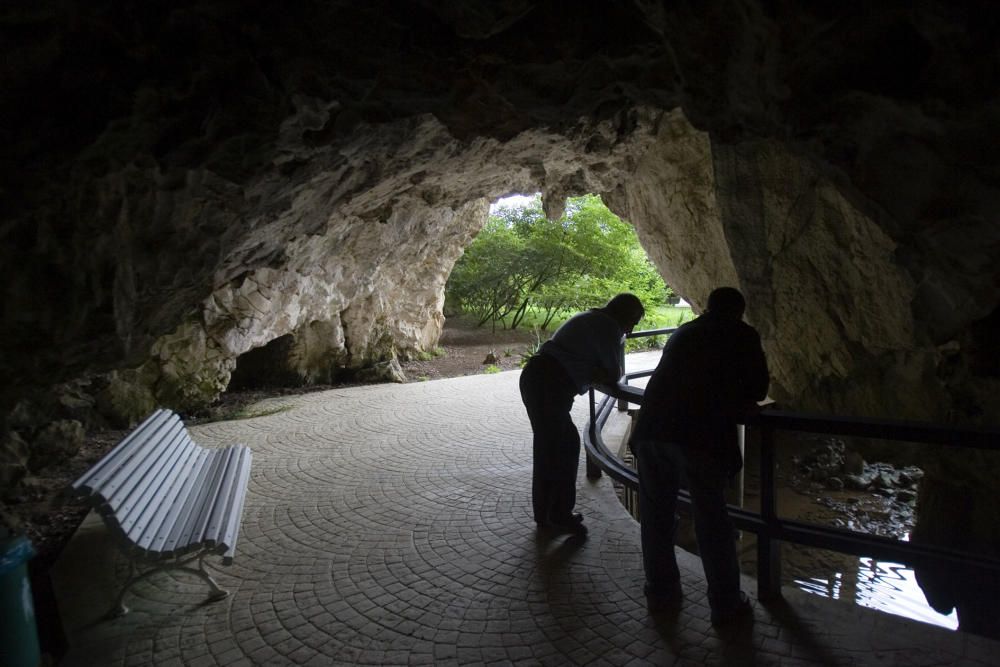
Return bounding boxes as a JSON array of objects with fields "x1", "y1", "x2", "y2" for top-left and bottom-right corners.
[{"x1": 520, "y1": 294, "x2": 645, "y2": 534}]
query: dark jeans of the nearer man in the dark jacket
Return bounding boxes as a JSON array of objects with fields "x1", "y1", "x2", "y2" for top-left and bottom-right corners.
[{"x1": 634, "y1": 440, "x2": 740, "y2": 609}]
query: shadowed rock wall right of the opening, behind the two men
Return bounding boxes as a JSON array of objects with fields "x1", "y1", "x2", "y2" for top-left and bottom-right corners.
[{"x1": 605, "y1": 111, "x2": 998, "y2": 422}]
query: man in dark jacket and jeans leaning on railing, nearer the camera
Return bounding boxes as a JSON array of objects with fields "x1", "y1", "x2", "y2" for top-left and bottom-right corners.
[{"x1": 629, "y1": 287, "x2": 768, "y2": 625}]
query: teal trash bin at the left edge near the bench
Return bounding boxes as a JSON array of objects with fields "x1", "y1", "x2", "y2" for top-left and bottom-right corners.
[{"x1": 0, "y1": 537, "x2": 41, "y2": 667}]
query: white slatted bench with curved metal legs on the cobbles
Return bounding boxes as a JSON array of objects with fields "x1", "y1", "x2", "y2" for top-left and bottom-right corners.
[{"x1": 73, "y1": 410, "x2": 251, "y2": 616}]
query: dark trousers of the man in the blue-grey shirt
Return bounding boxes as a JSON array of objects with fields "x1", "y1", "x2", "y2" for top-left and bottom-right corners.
[{"x1": 520, "y1": 355, "x2": 580, "y2": 523}]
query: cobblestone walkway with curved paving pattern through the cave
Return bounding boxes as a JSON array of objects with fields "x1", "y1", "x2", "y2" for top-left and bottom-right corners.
[{"x1": 54, "y1": 372, "x2": 1000, "y2": 666}]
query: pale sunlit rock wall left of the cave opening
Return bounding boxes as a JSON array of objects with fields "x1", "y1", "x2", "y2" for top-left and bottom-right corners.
[{"x1": 151, "y1": 200, "x2": 486, "y2": 409}]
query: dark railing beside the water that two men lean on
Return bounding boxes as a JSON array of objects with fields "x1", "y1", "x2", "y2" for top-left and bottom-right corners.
[{"x1": 584, "y1": 329, "x2": 1000, "y2": 599}]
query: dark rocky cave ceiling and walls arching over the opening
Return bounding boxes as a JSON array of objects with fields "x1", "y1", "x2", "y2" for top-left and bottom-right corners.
[{"x1": 0, "y1": 0, "x2": 1000, "y2": 422}]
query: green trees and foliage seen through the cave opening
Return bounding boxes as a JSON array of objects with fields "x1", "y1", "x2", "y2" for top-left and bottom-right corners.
[{"x1": 446, "y1": 195, "x2": 673, "y2": 329}]
